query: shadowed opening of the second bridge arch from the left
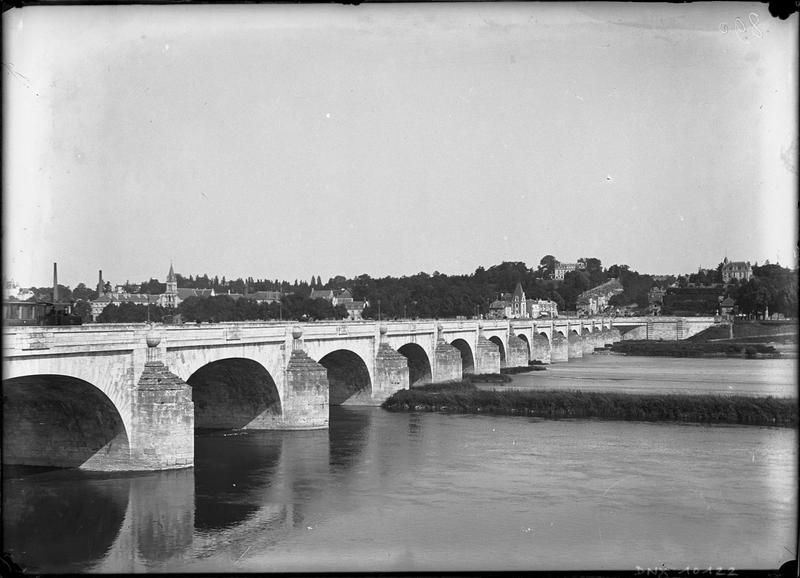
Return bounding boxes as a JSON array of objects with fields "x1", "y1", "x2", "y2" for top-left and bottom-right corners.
[{"x1": 186, "y1": 357, "x2": 282, "y2": 429}]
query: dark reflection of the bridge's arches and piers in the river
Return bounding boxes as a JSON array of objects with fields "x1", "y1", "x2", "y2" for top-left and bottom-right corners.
[{"x1": 4, "y1": 410, "x2": 380, "y2": 573}]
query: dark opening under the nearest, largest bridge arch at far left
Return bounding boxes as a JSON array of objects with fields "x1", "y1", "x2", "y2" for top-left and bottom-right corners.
[{"x1": 3, "y1": 374, "x2": 130, "y2": 471}]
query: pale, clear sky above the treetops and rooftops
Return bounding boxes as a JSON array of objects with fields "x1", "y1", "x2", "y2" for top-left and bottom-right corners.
[{"x1": 2, "y1": 2, "x2": 798, "y2": 287}]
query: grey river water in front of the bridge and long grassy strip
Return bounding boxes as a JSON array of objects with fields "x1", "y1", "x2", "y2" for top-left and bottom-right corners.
[{"x1": 3, "y1": 358, "x2": 798, "y2": 572}]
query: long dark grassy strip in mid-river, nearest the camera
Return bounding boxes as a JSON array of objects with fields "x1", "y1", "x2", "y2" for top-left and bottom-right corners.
[{"x1": 382, "y1": 381, "x2": 798, "y2": 427}]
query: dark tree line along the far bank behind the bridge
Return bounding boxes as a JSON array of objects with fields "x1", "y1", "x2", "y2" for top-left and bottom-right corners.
[{"x1": 17, "y1": 255, "x2": 798, "y2": 323}]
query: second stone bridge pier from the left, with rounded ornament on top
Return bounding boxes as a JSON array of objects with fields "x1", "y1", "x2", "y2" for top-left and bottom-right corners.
[{"x1": 281, "y1": 327, "x2": 329, "y2": 429}]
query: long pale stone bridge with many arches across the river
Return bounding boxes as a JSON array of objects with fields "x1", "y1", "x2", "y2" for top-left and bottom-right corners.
[{"x1": 3, "y1": 317, "x2": 714, "y2": 471}]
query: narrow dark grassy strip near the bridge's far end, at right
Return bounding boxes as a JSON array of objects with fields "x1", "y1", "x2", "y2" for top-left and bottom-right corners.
[{"x1": 611, "y1": 340, "x2": 780, "y2": 359}]
